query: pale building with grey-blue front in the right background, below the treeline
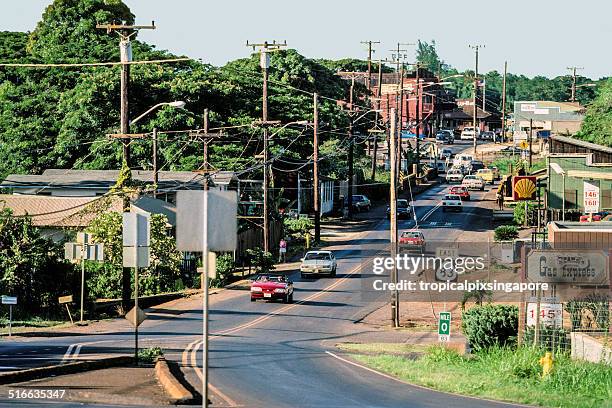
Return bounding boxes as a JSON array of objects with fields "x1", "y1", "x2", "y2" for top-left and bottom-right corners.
[{"x1": 513, "y1": 101, "x2": 585, "y2": 141}]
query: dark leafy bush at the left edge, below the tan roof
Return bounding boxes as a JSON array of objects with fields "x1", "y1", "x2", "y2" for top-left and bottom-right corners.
[{"x1": 0, "y1": 208, "x2": 73, "y2": 317}]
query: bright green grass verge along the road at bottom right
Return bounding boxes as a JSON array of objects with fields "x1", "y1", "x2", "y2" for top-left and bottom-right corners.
[{"x1": 346, "y1": 346, "x2": 612, "y2": 408}]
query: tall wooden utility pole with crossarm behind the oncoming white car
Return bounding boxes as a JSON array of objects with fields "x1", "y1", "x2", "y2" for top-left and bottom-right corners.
[{"x1": 246, "y1": 41, "x2": 287, "y2": 252}]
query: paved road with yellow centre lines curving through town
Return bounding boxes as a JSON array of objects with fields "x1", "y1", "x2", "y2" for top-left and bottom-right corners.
[{"x1": 0, "y1": 139, "x2": 506, "y2": 407}]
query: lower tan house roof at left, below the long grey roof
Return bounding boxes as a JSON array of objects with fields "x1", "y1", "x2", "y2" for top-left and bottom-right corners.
[{"x1": 0, "y1": 194, "x2": 176, "y2": 228}]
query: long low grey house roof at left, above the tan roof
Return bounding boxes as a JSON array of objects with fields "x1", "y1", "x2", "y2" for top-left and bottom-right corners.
[{"x1": 0, "y1": 169, "x2": 235, "y2": 190}]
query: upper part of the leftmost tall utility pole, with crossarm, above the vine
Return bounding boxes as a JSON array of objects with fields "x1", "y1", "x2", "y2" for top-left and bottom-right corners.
[{"x1": 96, "y1": 21, "x2": 155, "y2": 167}]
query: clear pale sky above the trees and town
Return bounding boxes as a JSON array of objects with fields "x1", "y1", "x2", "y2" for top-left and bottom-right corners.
[{"x1": 0, "y1": 0, "x2": 612, "y2": 79}]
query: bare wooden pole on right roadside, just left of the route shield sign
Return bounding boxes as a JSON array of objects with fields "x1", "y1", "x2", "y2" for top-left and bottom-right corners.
[{"x1": 389, "y1": 108, "x2": 399, "y2": 327}]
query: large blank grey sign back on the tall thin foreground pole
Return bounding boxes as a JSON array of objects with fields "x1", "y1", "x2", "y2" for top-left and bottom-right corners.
[{"x1": 176, "y1": 190, "x2": 238, "y2": 252}]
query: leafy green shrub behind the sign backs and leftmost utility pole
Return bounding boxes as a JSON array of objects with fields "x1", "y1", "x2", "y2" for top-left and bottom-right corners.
[{"x1": 86, "y1": 211, "x2": 181, "y2": 298}]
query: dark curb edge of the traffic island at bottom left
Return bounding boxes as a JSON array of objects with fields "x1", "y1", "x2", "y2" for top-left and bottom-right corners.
[{"x1": 0, "y1": 356, "x2": 134, "y2": 384}]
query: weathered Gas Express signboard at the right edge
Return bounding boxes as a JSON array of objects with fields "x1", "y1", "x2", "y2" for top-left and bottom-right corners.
[{"x1": 526, "y1": 249, "x2": 610, "y2": 285}]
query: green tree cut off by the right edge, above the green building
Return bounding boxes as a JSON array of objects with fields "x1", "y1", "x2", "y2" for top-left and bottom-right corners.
[{"x1": 576, "y1": 78, "x2": 612, "y2": 147}]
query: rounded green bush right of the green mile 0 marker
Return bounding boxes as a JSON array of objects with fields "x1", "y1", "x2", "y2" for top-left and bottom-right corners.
[{"x1": 461, "y1": 305, "x2": 518, "y2": 350}]
